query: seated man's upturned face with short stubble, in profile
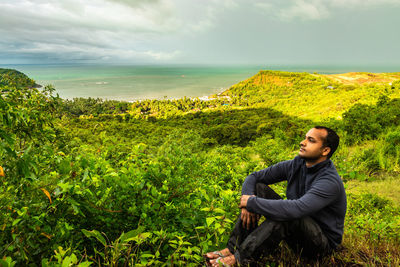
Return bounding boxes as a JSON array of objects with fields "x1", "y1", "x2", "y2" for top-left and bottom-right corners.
[{"x1": 299, "y1": 128, "x2": 330, "y2": 161}]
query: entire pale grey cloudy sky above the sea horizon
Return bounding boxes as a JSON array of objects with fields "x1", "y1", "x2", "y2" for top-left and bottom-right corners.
[{"x1": 0, "y1": 0, "x2": 400, "y2": 65}]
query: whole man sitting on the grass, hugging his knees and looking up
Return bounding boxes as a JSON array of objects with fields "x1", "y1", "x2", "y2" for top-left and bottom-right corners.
[{"x1": 205, "y1": 126, "x2": 347, "y2": 266}]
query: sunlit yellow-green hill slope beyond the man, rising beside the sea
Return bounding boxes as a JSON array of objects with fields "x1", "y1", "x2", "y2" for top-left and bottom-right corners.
[{"x1": 222, "y1": 71, "x2": 400, "y2": 121}]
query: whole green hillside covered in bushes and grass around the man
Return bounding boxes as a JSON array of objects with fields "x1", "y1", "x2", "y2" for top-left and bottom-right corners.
[{"x1": 0, "y1": 69, "x2": 400, "y2": 266}]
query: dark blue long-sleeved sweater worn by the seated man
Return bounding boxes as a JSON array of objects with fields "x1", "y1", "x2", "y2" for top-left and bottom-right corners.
[{"x1": 242, "y1": 156, "x2": 347, "y2": 248}]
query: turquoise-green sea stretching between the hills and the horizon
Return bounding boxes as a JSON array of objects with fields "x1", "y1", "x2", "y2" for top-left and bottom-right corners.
[{"x1": 0, "y1": 65, "x2": 400, "y2": 101}]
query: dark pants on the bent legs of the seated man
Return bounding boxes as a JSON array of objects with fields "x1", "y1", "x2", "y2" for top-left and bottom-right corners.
[{"x1": 227, "y1": 183, "x2": 331, "y2": 264}]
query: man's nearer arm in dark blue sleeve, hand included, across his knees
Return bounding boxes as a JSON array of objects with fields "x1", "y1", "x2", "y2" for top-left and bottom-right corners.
[{"x1": 240, "y1": 177, "x2": 340, "y2": 221}]
